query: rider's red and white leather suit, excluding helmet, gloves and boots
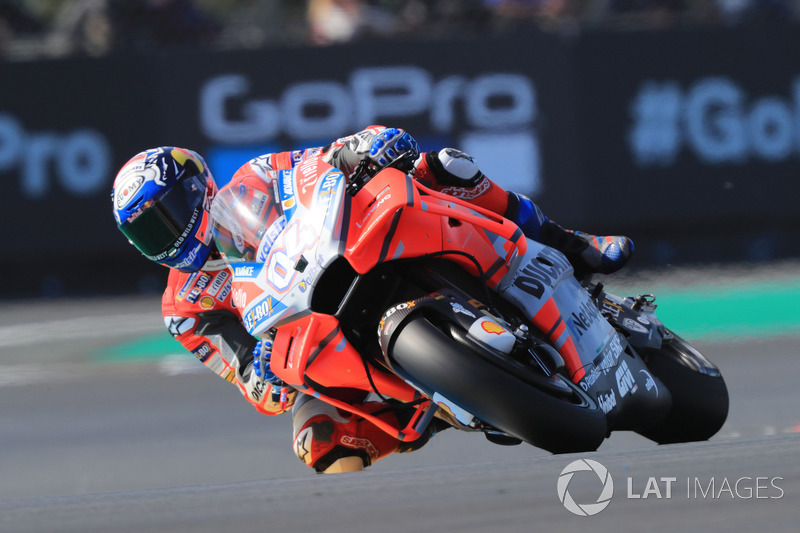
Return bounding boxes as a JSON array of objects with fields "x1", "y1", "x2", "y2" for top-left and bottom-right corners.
[{"x1": 162, "y1": 126, "x2": 540, "y2": 471}]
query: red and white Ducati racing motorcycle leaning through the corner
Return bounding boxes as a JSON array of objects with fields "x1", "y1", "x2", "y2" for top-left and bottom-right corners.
[{"x1": 212, "y1": 159, "x2": 728, "y2": 453}]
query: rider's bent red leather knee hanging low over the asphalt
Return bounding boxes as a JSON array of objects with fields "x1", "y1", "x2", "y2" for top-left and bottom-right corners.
[{"x1": 293, "y1": 395, "x2": 401, "y2": 474}]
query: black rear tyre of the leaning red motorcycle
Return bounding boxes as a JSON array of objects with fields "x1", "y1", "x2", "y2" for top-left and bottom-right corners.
[{"x1": 639, "y1": 335, "x2": 728, "y2": 444}]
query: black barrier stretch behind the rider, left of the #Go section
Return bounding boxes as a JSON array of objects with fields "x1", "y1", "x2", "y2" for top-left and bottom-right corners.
[{"x1": 0, "y1": 35, "x2": 576, "y2": 297}]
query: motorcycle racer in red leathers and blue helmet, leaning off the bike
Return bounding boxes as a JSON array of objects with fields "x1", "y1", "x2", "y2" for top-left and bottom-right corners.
[{"x1": 112, "y1": 126, "x2": 633, "y2": 472}]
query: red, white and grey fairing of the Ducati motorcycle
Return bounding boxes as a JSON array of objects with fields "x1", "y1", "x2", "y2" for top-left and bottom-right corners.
[{"x1": 212, "y1": 156, "x2": 720, "y2": 450}]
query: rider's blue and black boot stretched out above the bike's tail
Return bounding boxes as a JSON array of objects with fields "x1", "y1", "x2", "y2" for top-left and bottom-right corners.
[{"x1": 506, "y1": 193, "x2": 633, "y2": 278}]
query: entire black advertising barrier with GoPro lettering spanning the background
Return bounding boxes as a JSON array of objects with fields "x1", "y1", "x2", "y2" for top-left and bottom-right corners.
[{"x1": 0, "y1": 30, "x2": 800, "y2": 298}]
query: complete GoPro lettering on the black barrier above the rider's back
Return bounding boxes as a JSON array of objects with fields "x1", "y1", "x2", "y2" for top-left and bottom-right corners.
[{"x1": 200, "y1": 66, "x2": 537, "y2": 144}]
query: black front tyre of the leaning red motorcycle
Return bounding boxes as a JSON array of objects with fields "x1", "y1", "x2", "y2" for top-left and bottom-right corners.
[{"x1": 389, "y1": 314, "x2": 607, "y2": 453}]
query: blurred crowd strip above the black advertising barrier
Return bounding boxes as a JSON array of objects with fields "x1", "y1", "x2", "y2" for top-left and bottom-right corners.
[{"x1": 0, "y1": 0, "x2": 800, "y2": 61}]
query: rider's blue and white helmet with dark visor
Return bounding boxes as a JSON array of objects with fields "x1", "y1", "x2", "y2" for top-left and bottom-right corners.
[{"x1": 111, "y1": 146, "x2": 217, "y2": 272}]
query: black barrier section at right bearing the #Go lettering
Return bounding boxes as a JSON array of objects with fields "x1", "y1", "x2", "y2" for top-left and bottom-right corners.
[{"x1": 575, "y1": 26, "x2": 800, "y2": 262}]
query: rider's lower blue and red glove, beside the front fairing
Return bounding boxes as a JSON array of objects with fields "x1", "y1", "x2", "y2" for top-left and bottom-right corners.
[{"x1": 237, "y1": 340, "x2": 297, "y2": 415}]
